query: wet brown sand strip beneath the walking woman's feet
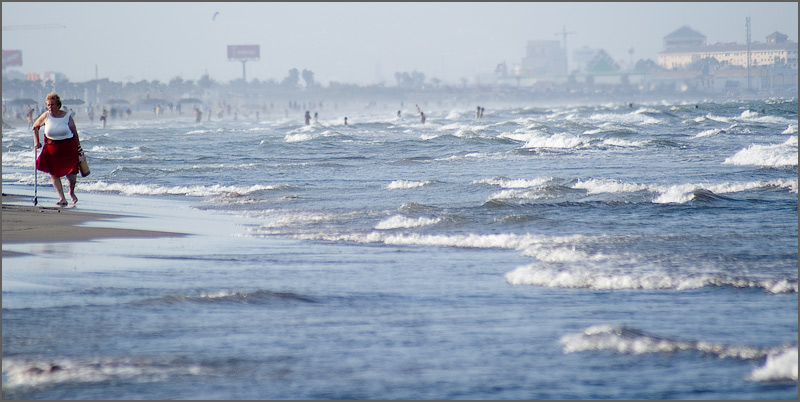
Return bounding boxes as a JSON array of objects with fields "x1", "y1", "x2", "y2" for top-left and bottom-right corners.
[{"x1": 2, "y1": 194, "x2": 182, "y2": 257}]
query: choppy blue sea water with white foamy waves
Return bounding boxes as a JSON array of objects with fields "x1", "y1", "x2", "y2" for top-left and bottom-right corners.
[{"x1": 2, "y1": 99, "x2": 798, "y2": 399}]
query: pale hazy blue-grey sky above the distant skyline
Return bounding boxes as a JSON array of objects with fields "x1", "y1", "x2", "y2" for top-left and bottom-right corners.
[{"x1": 2, "y1": 1, "x2": 798, "y2": 86}]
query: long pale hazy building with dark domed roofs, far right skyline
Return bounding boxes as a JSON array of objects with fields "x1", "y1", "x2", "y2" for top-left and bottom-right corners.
[{"x1": 658, "y1": 27, "x2": 797, "y2": 70}]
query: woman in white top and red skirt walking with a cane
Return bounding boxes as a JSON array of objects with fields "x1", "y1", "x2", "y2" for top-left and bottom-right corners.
[{"x1": 33, "y1": 92, "x2": 81, "y2": 206}]
